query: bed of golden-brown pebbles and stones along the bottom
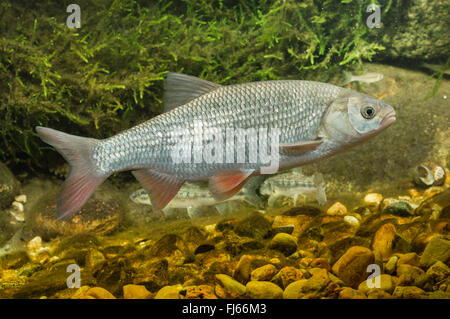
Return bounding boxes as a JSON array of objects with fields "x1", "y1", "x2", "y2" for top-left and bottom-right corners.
[{"x1": 0, "y1": 183, "x2": 450, "y2": 299}]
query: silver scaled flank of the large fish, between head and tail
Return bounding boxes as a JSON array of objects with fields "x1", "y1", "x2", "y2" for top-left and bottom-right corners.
[{"x1": 93, "y1": 80, "x2": 342, "y2": 179}]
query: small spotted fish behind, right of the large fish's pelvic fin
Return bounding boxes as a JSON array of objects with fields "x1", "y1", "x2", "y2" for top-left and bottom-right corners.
[{"x1": 260, "y1": 169, "x2": 327, "y2": 207}]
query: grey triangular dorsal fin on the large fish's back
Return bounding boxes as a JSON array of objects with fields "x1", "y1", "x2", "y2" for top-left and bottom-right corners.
[{"x1": 164, "y1": 72, "x2": 220, "y2": 112}]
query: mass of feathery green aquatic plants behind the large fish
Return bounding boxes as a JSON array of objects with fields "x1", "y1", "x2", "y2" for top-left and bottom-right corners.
[{"x1": 0, "y1": 0, "x2": 383, "y2": 170}]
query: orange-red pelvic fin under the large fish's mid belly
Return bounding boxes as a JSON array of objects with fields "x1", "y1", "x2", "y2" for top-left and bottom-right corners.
[{"x1": 209, "y1": 170, "x2": 253, "y2": 200}]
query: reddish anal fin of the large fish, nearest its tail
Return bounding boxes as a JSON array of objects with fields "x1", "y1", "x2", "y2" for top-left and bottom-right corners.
[{"x1": 132, "y1": 169, "x2": 184, "y2": 210}]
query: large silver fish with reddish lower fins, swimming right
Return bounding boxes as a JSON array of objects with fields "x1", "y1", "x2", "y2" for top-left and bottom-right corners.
[{"x1": 36, "y1": 73, "x2": 395, "y2": 219}]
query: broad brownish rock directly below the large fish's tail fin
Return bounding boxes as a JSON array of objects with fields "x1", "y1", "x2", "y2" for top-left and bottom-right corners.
[{"x1": 26, "y1": 198, "x2": 122, "y2": 240}]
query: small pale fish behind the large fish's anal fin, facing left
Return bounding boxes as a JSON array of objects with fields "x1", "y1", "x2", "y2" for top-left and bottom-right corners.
[{"x1": 130, "y1": 176, "x2": 264, "y2": 218}]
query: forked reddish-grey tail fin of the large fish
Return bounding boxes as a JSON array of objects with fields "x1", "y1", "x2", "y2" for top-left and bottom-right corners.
[{"x1": 36, "y1": 126, "x2": 109, "y2": 219}]
